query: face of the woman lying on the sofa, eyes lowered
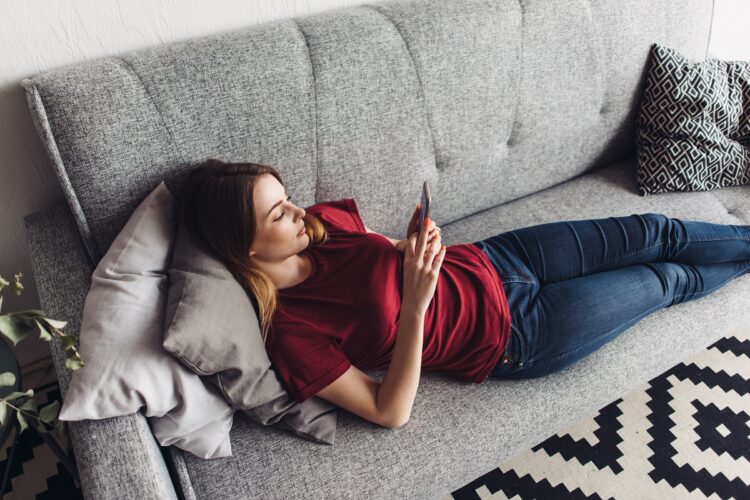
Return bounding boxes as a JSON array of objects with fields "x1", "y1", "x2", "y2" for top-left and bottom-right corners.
[{"x1": 250, "y1": 174, "x2": 310, "y2": 262}]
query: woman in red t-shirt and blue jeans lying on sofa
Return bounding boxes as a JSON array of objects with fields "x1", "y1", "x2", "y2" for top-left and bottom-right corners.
[{"x1": 180, "y1": 160, "x2": 750, "y2": 428}]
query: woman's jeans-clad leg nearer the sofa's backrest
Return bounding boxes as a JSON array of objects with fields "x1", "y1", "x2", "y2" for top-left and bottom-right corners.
[{"x1": 474, "y1": 213, "x2": 750, "y2": 285}]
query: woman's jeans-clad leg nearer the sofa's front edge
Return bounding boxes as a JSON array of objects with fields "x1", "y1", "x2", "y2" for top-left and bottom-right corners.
[{"x1": 490, "y1": 259, "x2": 750, "y2": 378}]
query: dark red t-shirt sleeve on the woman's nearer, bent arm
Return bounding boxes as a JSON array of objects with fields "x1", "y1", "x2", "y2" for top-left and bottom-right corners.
[{"x1": 267, "y1": 329, "x2": 351, "y2": 403}]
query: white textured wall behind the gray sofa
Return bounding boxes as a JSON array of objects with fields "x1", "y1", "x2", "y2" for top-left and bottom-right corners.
[{"x1": 0, "y1": 0, "x2": 750, "y2": 372}]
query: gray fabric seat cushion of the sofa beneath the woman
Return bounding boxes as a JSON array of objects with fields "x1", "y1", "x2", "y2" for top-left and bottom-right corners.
[{"x1": 170, "y1": 158, "x2": 750, "y2": 498}]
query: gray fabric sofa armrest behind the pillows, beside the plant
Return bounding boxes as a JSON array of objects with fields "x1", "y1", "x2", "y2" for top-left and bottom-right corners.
[{"x1": 24, "y1": 203, "x2": 177, "y2": 499}]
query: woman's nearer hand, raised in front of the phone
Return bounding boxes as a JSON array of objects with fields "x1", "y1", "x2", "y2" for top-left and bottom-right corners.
[{"x1": 402, "y1": 219, "x2": 446, "y2": 314}]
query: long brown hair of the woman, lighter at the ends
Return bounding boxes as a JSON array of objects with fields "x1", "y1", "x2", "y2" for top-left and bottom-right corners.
[{"x1": 179, "y1": 158, "x2": 328, "y2": 343}]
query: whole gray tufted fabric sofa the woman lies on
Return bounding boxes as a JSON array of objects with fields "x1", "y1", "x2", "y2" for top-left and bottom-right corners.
[{"x1": 23, "y1": 0, "x2": 750, "y2": 499}]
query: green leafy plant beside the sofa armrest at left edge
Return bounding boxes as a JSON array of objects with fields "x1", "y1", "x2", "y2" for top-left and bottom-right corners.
[{"x1": 0, "y1": 272, "x2": 83, "y2": 491}]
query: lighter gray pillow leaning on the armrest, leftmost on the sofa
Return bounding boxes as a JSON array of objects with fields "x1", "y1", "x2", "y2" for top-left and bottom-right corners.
[{"x1": 59, "y1": 182, "x2": 235, "y2": 458}]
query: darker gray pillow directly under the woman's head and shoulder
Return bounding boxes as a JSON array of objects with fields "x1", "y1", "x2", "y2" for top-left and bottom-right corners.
[{"x1": 163, "y1": 222, "x2": 337, "y2": 445}]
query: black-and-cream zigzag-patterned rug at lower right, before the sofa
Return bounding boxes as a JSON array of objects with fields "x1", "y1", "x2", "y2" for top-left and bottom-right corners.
[{"x1": 441, "y1": 327, "x2": 750, "y2": 500}]
